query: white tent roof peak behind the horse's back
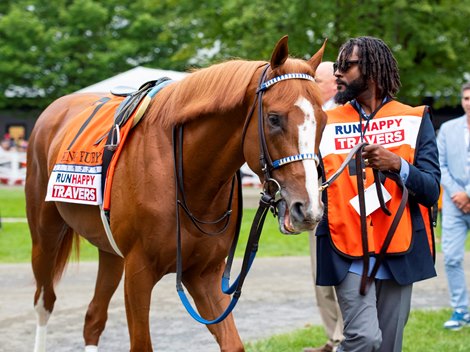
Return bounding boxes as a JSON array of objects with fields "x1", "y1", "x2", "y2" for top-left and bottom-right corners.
[{"x1": 76, "y1": 66, "x2": 188, "y2": 93}]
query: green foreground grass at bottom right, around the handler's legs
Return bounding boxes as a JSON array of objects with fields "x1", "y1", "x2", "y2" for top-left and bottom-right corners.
[{"x1": 246, "y1": 309, "x2": 470, "y2": 352}]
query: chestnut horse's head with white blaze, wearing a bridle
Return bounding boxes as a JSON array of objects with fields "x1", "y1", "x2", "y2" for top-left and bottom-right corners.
[{"x1": 244, "y1": 36, "x2": 326, "y2": 234}]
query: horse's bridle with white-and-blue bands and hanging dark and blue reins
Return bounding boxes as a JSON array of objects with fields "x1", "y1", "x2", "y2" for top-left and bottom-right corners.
[{"x1": 173, "y1": 64, "x2": 319, "y2": 325}]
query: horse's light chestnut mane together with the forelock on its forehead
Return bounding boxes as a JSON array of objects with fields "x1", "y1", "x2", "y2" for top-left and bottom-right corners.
[{"x1": 148, "y1": 58, "x2": 322, "y2": 126}]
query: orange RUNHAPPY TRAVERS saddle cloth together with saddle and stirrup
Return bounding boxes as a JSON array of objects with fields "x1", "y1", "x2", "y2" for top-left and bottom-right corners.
[{"x1": 46, "y1": 78, "x2": 172, "y2": 210}]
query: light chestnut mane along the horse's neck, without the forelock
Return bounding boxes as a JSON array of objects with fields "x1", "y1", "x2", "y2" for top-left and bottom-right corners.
[{"x1": 149, "y1": 60, "x2": 266, "y2": 125}]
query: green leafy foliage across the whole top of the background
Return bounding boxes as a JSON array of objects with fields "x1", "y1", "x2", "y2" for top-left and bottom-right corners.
[{"x1": 0, "y1": 0, "x2": 470, "y2": 108}]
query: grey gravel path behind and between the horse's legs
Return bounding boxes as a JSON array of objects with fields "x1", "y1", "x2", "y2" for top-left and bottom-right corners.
[{"x1": 0, "y1": 255, "x2": 462, "y2": 352}]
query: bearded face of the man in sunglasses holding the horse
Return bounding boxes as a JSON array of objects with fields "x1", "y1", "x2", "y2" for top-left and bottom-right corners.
[{"x1": 335, "y1": 47, "x2": 368, "y2": 104}]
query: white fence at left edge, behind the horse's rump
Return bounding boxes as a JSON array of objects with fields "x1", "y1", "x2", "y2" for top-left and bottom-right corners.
[{"x1": 0, "y1": 148, "x2": 26, "y2": 185}]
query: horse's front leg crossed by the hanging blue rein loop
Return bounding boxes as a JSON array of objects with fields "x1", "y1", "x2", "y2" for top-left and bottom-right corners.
[{"x1": 183, "y1": 262, "x2": 245, "y2": 352}]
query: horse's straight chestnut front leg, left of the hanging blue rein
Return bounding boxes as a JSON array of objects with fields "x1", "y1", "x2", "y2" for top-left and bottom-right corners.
[{"x1": 124, "y1": 250, "x2": 157, "y2": 352}]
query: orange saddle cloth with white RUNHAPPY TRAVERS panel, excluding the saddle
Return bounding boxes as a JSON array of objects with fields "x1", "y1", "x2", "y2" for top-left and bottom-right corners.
[{"x1": 46, "y1": 96, "x2": 135, "y2": 209}]
